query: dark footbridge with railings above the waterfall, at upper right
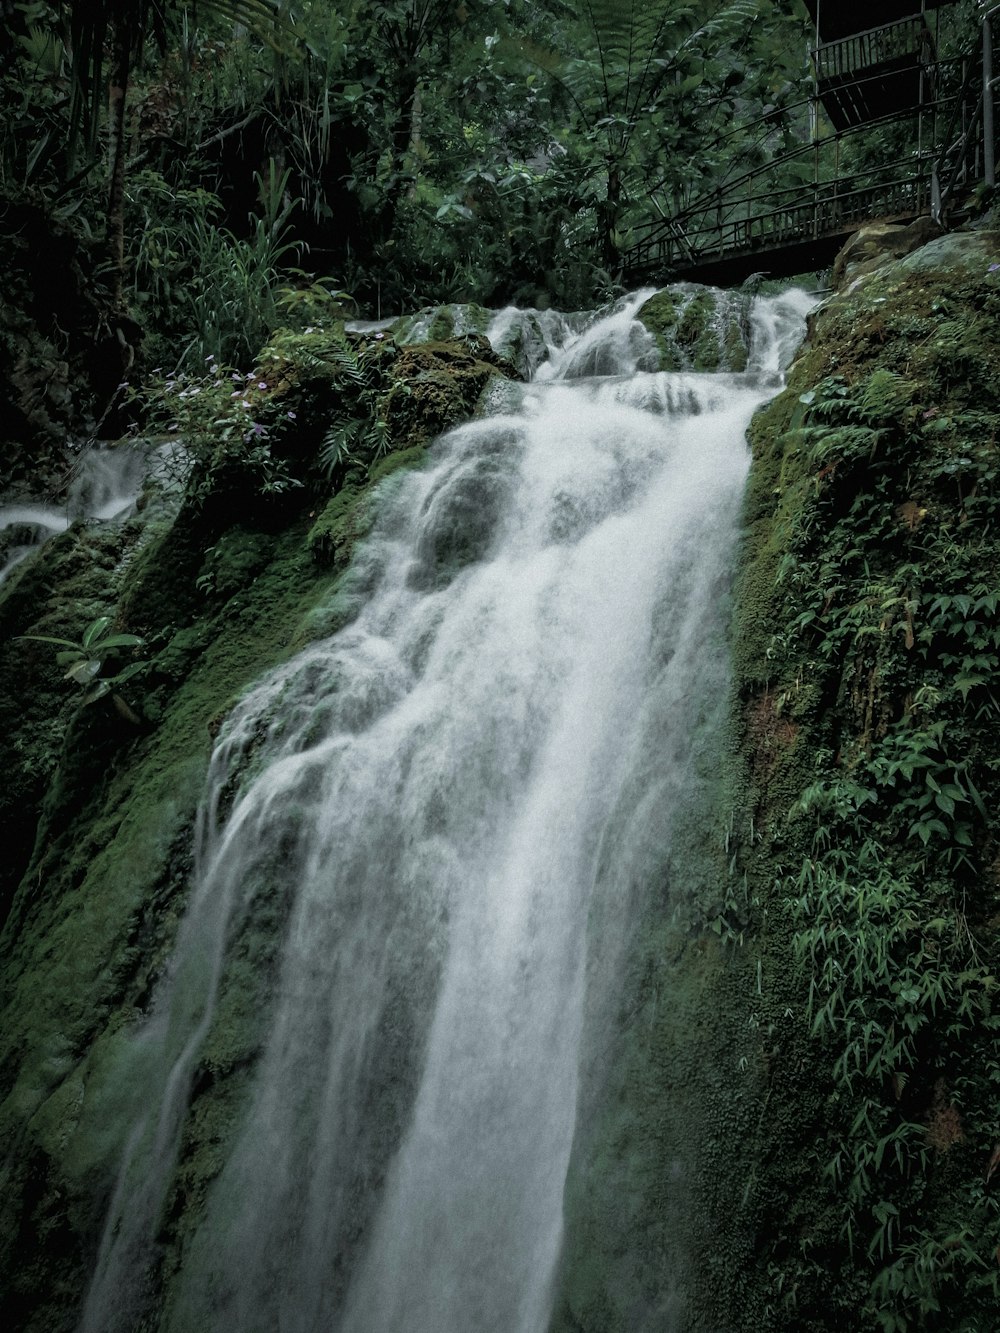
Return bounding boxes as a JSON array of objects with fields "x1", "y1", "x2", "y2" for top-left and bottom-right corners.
[{"x1": 624, "y1": 0, "x2": 1000, "y2": 285}]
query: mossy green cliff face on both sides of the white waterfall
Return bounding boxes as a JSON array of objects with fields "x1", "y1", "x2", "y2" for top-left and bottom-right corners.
[{"x1": 0, "y1": 232, "x2": 1000, "y2": 1333}]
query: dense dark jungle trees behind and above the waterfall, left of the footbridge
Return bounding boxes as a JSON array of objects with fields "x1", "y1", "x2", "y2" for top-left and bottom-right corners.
[{"x1": 0, "y1": 0, "x2": 976, "y2": 458}]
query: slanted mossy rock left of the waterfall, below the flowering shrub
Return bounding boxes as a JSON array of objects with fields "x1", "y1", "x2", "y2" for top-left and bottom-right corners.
[{"x1": 0, "y1": 397, "x2": 437, "y2": 1329}]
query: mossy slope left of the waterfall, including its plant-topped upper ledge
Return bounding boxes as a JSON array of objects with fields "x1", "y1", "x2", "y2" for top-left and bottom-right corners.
[{"x1": 0, "y1": 329, "x2": 512, "y2": 1333}]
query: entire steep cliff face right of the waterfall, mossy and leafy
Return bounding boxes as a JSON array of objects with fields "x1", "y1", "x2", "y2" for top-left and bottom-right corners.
[{"x1": 556, "y1": 232, "x2": 1000, "y2": 1333}]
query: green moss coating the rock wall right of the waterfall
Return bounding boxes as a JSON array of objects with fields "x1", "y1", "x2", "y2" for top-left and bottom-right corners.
[{"x1": 705, "y1": 237, "x2": 1000, "y2": 1330}]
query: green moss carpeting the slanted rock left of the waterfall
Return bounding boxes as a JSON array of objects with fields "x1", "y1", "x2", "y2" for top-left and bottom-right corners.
[{"x1": 0, "y1": 461, "x2": 419, "y2": 1328}]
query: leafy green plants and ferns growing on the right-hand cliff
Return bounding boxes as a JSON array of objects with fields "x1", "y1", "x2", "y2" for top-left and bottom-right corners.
[{"x1": 744, "y1": 261, "x2": 1000, "y2": 1333}]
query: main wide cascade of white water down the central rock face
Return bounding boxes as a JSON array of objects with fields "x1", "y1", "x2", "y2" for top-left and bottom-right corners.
[{"x1": 81, "y1": 293, "x2": 809, "y2": 1333}]
